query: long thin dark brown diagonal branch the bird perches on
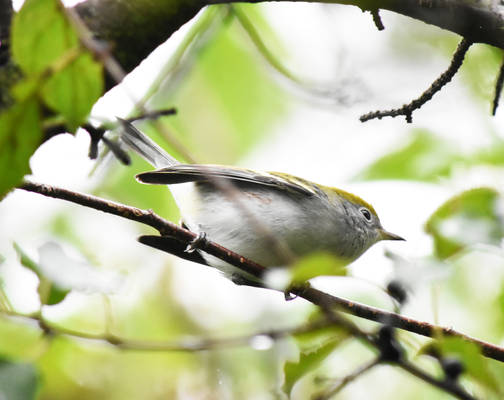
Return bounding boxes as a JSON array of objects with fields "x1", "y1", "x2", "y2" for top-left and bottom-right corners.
[{"x1": 19, "y1": 182, "x2": 504, "y2": 362}]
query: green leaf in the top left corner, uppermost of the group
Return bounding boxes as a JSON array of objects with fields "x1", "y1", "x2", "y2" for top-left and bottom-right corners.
[{"x1": 11, "y1": 0, "x2": 79, "y2": 75}]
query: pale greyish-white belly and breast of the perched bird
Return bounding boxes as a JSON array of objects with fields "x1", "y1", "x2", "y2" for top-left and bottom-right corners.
[{"x1": 170, "y1": 183, "x2": 354, "y2": 273}]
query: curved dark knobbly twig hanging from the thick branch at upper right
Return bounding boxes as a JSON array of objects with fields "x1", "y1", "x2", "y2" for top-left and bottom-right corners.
[{"x1": 360, "y1": 38, "x2": 472, "y2": 123}]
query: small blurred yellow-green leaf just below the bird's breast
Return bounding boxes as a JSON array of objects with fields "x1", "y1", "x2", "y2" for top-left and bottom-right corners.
[{"x1": 289, "y1": 252, "x2": 348, "y2": 283}]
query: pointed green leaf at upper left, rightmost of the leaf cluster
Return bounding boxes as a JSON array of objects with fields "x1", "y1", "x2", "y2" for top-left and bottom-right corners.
[{"x1": 42, "y1": 53, "x2": 103, "y2": 132}]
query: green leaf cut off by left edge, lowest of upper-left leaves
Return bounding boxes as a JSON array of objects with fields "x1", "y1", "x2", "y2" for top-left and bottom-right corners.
[{"x1": 0, "y1": 99, "x2": 42, "y2": 199}]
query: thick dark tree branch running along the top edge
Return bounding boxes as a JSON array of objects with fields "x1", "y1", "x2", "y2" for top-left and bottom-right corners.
[{"x1": 69, "y1": 0, "x2": 504, "y2": 89}]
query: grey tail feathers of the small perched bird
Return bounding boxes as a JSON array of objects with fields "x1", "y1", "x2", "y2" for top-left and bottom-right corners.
[{"x1": 117, "y1": 117, "x2": 180, "y2": 168}]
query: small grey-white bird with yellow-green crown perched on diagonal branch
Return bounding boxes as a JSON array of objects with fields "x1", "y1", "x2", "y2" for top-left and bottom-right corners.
[{"x1": 119, "y1": 119, "x2": 404, "y2": 278}]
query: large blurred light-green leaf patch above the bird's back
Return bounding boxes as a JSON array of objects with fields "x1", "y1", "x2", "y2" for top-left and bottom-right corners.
[{"x1": 151, "y1": 8, "x2": 289, "y2": 164}]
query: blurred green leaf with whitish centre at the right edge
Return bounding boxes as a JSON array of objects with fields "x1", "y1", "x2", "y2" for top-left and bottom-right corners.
[{"x1": 425, "y1": 188, "x2": 504, "y2": 259}]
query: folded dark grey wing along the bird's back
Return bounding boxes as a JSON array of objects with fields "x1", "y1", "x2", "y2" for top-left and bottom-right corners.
[{"x1": 132, "y1": 164, "x2": 319, "y2": 196}]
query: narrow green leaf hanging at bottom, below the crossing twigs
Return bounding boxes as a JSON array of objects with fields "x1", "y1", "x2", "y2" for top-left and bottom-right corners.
[{"x1": 282, "y1": 332, "x2": 341, "y2": 395}]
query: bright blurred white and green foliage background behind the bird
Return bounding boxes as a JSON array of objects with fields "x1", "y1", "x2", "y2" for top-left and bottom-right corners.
[{"x1": 0, "y1": 4, "x2": 504, "y2": 399}]
